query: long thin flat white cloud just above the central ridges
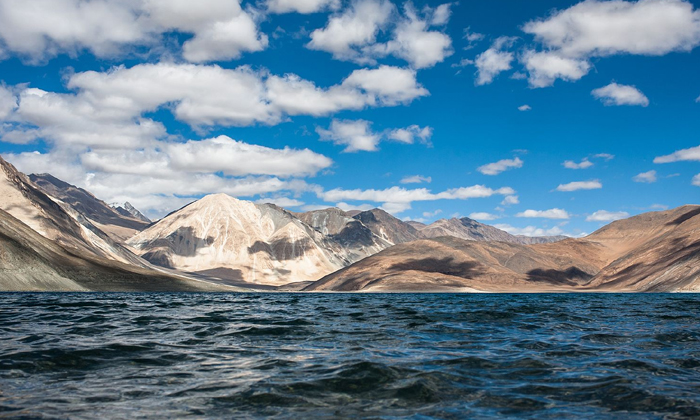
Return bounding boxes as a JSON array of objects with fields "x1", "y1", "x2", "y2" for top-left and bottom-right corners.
[{"x1": 316, "y1": 185, "x2": 515, "y2": 213}]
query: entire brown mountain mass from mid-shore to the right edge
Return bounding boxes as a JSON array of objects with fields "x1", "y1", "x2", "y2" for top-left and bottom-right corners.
[{"x1": 305, "y1": 206, "x2": 700, "y2": 292}]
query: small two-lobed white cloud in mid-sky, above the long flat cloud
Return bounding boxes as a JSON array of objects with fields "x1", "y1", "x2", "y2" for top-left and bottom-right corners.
[{"x1": 316, "y1": 119, "x2": 433, "y2": 152}]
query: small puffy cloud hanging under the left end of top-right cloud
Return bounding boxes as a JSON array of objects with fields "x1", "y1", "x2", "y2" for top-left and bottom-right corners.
[{"x1": 521, "y1": 51, "x2": 591, "y2": 88}]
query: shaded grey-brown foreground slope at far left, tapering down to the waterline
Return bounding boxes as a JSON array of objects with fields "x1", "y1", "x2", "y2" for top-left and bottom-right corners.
[{"x1": 0, "y1": 210, "x2": 231, "y2": 291}]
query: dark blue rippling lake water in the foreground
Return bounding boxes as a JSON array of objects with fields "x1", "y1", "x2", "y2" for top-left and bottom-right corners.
[{"x1": 0, "y1": 294, "x2": 700, "y2": 419}]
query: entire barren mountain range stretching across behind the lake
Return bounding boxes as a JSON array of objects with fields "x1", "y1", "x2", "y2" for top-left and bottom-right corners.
[{"x1": 0, "y1": 154, "x2": 700, "y2": 292}]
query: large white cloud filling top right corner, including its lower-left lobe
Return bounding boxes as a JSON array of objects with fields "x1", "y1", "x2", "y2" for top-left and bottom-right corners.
[{"x1": 522, "y1": 0, "x2": 700, "y2": 87}]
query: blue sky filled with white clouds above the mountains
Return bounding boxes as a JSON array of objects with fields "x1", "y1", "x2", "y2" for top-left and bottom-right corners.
[{"x1": 0, "y1": 0, "x2": 700, "y2": 236}]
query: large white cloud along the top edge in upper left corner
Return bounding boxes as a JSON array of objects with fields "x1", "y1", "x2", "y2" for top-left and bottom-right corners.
[{"x1": 0, "y1": 0, "x2": 268, "y2": 62}]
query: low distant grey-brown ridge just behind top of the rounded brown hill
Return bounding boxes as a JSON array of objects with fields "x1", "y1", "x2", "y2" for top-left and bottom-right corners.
[{"x1": 418, "y1": 217, "x2": 566, "y2": 245}]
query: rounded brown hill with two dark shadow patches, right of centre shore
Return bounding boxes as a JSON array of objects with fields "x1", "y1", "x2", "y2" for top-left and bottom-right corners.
[{"x1": 305, "y1": 236, "x2": 599, "y2": 291}]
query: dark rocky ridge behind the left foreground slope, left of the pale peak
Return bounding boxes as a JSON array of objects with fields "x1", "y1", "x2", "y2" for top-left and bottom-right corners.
[{"x1": 29, "y1": 174, "x2": 150, "y2": 242}]
